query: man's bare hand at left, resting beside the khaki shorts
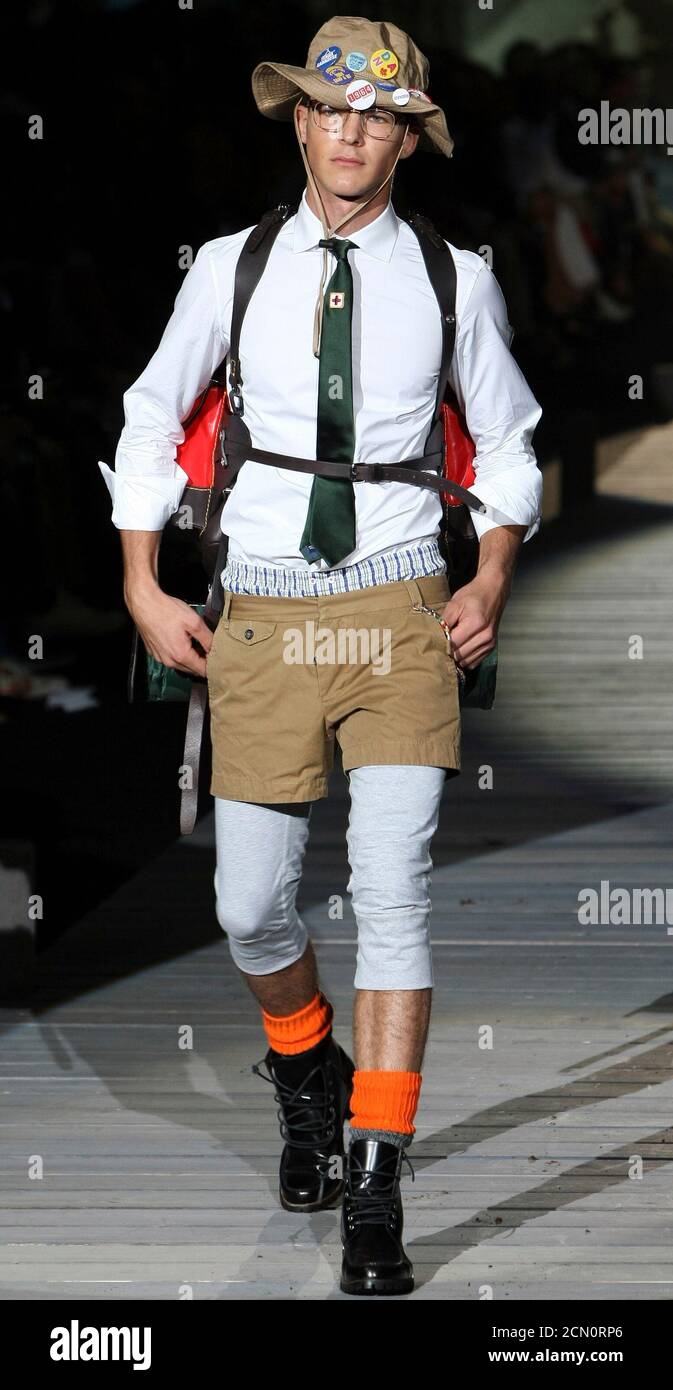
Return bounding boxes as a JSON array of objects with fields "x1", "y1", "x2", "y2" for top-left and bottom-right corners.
[{"x1": 127, "y1": 584, "x2": 213, "y2": 676}]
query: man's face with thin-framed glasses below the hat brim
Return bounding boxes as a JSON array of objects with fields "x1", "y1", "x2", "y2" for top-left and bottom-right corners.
[{"x1": 298, "y1": 106, "x2": 419, "y2": 200}]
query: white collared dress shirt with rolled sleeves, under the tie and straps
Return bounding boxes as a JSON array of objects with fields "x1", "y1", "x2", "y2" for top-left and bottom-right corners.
[{"x1": 99, "y1": 184, "x2": 542, "y2": 569}]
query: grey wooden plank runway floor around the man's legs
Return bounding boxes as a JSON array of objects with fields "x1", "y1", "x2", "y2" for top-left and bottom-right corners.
[{"x1": 0, "y1": 464, "x2": 673, "y2": 1302}]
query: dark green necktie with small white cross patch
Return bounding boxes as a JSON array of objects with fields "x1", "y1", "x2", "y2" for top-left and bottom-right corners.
[{"x1": 299, "y1": 236, "x2": 357, "y2": 564}]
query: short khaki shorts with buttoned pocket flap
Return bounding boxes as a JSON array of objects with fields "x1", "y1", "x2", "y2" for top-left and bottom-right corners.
[{"x1": 207, "y1": 574, "x2": 460, "y2": 800}]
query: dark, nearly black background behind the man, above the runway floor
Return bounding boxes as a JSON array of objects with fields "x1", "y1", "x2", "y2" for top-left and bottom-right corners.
[{"x1": 0, "y1": 0, "x2": 673, "y2": 947}]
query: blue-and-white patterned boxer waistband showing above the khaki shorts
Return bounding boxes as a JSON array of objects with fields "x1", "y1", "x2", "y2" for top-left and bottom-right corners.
[{"x1": 222, "y1": 538, "x2": 446, "y2": 598}]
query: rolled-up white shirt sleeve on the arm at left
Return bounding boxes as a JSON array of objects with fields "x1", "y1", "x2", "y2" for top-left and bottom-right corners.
[{"x1": 99, "y1": 242, "x2": 228, "y2": 531}]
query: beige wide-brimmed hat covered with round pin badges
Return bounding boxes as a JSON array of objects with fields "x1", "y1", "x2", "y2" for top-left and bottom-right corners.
[{"x1": 252, "y1": 15, "x2": 453, "y2": 158}]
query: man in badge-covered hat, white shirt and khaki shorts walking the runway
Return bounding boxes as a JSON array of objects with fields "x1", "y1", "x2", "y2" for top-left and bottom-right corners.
[{"x1": 103, "y1": 17, "x2": 541, "y2": 1294}]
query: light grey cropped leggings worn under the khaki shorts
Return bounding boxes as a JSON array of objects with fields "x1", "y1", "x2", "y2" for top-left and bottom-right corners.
[{"x1": 214, "y1": 765, "x2": 446, "y2": 990}]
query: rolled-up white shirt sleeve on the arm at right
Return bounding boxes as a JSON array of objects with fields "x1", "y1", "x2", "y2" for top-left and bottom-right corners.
[{"x1": 449, "y1": 261, "x2": 542, "y2": 541}]
